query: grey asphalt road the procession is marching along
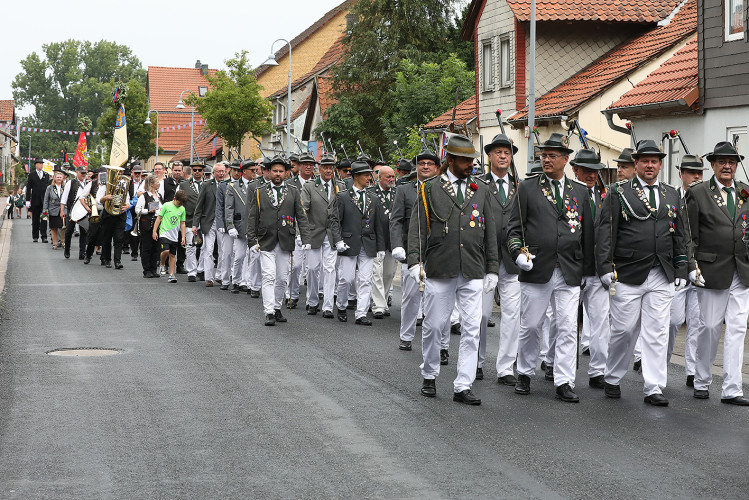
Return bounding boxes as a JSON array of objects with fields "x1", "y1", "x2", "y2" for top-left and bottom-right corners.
[{"x1": 0, "y1": 219, "x2": 749, "y2": 499}]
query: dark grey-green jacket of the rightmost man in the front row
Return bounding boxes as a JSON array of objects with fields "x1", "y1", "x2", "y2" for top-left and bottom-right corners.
[{"x1": 686, "y1": 177, "x2": 749, "y2": 290}]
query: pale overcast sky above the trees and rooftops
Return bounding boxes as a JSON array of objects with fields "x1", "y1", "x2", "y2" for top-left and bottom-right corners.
[{"x1": 0, "y1": 0, "x2": 343, "y2": 119}]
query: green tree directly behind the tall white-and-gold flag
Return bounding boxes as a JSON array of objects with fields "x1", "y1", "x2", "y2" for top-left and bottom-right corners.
[{"x1": 96, "y1": 80, "x2": 156, "y2": 163}]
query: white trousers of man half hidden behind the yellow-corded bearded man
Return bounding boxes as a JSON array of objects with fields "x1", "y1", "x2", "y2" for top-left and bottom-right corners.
[{"x1": 479, "y1": 262, "x2": 520, "y2": 377}]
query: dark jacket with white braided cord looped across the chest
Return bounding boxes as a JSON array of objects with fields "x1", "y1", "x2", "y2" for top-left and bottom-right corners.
[{"x1": 596, "y1": 178, "x2": 688, "y2": 285}]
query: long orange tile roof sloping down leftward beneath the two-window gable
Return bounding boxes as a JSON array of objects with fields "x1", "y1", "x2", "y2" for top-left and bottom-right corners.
[{"x1": 508, "y1": 0, "x2": 697, "y2": 122}]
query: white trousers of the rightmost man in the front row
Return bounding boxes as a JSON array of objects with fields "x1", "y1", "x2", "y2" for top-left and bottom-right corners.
[{"x1": 692, "y1": 272, "x2": 749, "y2": 398}]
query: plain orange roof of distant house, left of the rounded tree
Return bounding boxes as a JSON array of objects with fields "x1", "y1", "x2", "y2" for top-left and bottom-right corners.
[{"x1": 148, "y1": 66, "x2": 218, "y2": 112}]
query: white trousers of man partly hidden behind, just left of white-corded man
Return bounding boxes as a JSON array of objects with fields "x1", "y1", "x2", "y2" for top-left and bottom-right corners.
[{"x1": 580, "y1": 275, "x2": 611, "y2": 377}]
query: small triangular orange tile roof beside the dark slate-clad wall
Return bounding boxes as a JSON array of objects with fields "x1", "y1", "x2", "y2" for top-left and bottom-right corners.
[{"x1": 608, "y1": 36, "x2": 699, "y2": 109}]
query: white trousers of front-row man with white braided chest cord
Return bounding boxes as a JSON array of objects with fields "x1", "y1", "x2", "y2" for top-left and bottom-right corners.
[{"x1": 604, "y1": 266, "x2": 674, "y2": 396}]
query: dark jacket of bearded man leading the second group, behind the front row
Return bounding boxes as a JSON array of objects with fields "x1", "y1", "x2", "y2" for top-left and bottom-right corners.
[{"x1": 247, "y1": 182, "x2": 309, "y2": 252}]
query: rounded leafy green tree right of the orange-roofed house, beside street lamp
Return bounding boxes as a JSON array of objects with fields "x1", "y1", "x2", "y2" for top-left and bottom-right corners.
[{"x1": 186, "y1": 51, "x2": 273, "y2": 154}]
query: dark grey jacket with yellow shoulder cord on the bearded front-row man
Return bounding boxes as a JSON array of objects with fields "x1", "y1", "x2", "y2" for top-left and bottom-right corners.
[{"x1": 407, "y1": 174, "x2": 499, "y2": 279}]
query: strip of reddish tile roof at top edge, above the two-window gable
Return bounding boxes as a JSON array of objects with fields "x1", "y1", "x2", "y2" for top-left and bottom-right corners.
[{"x1": 507, "y1": 0, "x2": 681, "y2": 23}]
